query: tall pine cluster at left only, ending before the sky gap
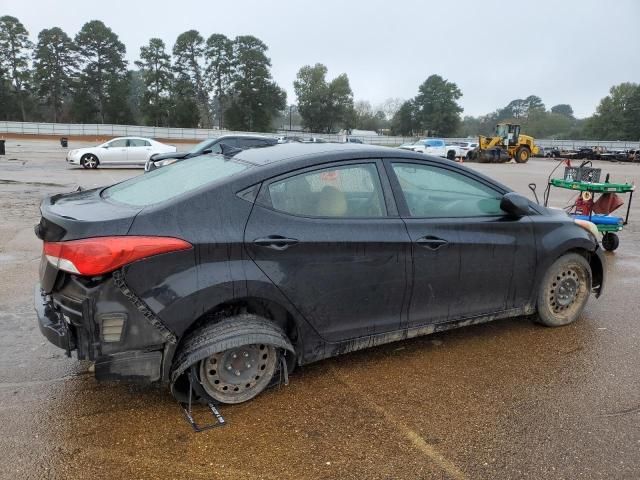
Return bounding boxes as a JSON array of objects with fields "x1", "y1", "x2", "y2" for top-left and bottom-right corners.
[{"x1": 0, "y1": 16, "x2": 286, "y2": 131}]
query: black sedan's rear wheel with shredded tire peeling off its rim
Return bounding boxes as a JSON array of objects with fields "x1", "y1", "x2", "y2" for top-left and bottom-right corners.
[{"x1": 171, "y1": 314, "x2": 293, "y2": 404}]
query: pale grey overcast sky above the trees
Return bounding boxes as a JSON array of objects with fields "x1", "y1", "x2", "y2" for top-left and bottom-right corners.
[{"x1": 5, "y1": 0, "x2": 640, "y2": 117}]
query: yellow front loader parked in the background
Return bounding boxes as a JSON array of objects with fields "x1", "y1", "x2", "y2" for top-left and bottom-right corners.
[{"x1": 467, "y1": 123, "x2": 539, "y2": 163}]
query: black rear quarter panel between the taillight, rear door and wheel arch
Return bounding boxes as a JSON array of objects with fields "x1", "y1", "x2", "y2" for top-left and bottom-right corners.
[{"x1": 126, "y1": 185, "x2": 252, "y2": 336}]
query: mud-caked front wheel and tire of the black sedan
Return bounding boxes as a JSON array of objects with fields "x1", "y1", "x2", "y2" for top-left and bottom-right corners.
[{"x1": 537, "y1": 253, "x2": 592, "y2": 327}]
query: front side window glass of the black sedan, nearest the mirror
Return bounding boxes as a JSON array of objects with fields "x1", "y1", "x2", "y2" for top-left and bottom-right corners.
[{"x1": 393, "y1": 162, "x2": 504, "y2": 218}]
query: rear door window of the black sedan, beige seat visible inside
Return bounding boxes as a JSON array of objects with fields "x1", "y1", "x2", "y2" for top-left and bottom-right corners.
[{"x1": 269, "y1": 163, "x2": 386, "y2": 218}]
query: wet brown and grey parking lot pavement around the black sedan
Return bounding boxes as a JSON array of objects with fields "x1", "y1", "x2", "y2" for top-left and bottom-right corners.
[{"x1": 0, "y1": 139, "x2": 640, "y2": 479}]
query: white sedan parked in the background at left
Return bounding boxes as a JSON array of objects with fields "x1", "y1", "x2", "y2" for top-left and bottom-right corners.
[{"x1": 67, "y1": 137, "x2": 177, "y2": 168}]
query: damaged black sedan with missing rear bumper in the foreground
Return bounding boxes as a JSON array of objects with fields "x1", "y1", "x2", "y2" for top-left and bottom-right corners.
[{"x1": 35, "y1": 143, "x2": 605, "y2": 403}]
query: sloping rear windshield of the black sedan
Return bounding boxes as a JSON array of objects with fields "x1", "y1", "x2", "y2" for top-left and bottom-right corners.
[{"x1": 102, "y1": 155, "x2": 250, "y2": 207}]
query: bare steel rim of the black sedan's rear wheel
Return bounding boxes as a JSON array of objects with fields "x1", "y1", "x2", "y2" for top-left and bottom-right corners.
[{"x1": 200, "y1": 344, "x2": 277, "y2": 403}]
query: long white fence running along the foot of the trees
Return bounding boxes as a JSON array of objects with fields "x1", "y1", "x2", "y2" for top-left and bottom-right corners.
[{"x1": 0, "y1": 122, "x2": 640, "y2": 150}]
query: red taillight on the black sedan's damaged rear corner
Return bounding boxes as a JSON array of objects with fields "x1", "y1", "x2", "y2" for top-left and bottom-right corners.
[{"x1": 44, "y1": 236, "x2": 192, "y2": 276}]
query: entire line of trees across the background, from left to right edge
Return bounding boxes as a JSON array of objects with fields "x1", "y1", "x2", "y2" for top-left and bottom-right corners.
[{"x1": 0, "y1": 15, "x2": 640, "y2": 141}]
